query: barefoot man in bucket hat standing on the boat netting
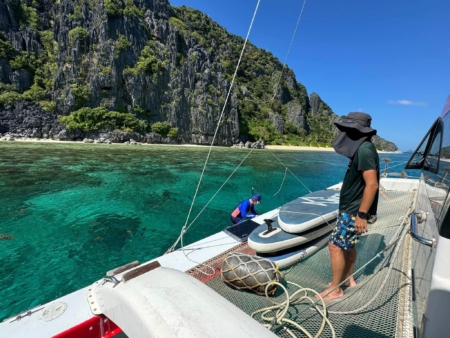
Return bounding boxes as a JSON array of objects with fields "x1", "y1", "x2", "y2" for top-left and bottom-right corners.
[{"x1": 321, "y1": 113, "x2": 380, "y2": 300}]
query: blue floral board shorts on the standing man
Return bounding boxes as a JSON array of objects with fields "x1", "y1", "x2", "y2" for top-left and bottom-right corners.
[{"x1": 329, "y1": 213, "x2": 361, "y2": 251}]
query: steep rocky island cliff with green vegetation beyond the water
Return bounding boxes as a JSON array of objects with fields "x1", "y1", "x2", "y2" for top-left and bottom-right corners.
[{"x1": 0, "y1": 0, "x2": 397, "y2": 151}]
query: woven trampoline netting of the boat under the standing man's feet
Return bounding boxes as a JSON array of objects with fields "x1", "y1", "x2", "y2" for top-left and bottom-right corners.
[{"x1": 190, "y1": 191, "x2": 414, "y2": 338}]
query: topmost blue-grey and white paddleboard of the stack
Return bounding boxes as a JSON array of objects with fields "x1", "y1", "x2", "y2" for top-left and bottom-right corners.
[{"x1": 278, "y1": 190, "x2": 340, "y2": 233}]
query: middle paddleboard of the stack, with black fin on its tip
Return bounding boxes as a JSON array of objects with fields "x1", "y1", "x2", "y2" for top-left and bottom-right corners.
[{"x1": 247, "y1": 220, "x2": 335, "y2": 253}]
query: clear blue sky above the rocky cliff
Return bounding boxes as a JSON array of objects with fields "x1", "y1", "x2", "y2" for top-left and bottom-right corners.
[{"x1": 169, "y1": 0, "x2": 450, "y2": 151}]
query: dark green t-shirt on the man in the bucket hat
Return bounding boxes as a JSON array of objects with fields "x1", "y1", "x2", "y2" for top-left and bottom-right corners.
[{"x1": 339, "y1": 141, "x2": 380, "y2": 215}]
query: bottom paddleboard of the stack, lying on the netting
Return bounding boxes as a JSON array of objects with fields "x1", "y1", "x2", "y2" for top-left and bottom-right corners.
[{"x1": 256, "y1": 230, "x2": 331, "y2": 268}]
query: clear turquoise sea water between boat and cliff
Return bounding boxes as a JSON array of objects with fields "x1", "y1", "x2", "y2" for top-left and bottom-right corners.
[{"x1": 0, "y1": 142, "x2": 410, "y2": 320}]
